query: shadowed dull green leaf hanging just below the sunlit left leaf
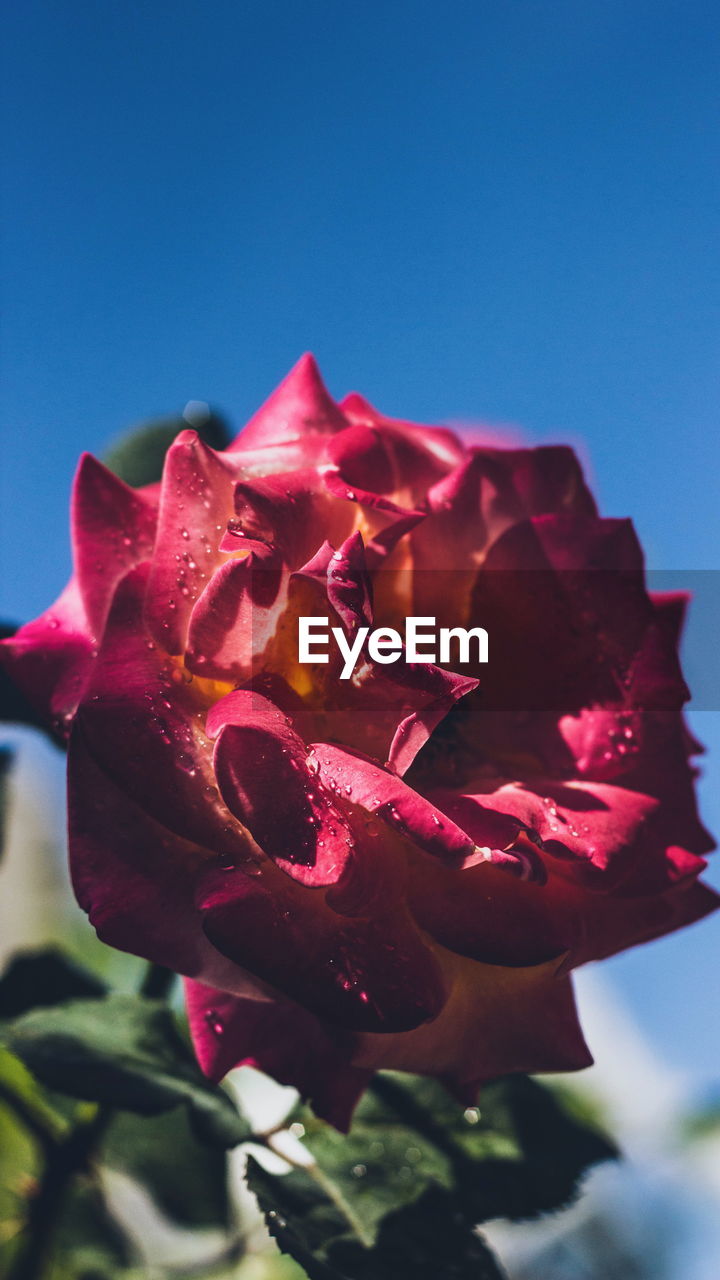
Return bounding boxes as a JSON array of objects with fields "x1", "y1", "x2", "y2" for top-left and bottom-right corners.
[{"x1": 102, "y1": 1107, "x2": 229, "y2": 1229}]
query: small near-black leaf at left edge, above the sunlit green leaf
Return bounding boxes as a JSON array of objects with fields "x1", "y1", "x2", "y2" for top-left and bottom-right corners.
[{"x1": 0, "y1": 947, "x2": 106, "y2": 1019}]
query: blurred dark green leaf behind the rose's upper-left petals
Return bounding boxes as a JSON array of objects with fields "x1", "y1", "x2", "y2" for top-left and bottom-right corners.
[{"x1": 104, "y1": 406, "x2": 231, "y2": 488}]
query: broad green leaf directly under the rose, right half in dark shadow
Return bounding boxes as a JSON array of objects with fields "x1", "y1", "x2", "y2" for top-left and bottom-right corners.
[{"x1": 294, "y1": 1073, "x2": 616, "y2": 1234}]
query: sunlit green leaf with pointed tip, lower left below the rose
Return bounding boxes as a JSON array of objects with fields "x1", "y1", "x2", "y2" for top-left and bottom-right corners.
[{"x1": 4, "y1": 995, "x2": 249, "y2": 1147}]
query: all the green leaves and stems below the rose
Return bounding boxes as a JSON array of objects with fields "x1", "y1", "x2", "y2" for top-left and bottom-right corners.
[{"x1": 0, "y1": 948, "x2": 615, "y2": 1280}]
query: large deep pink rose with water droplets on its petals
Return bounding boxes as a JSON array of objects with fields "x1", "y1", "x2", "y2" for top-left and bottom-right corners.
[{"x1": 4, "y1": 357, "x2": 716, "y2": 1126}]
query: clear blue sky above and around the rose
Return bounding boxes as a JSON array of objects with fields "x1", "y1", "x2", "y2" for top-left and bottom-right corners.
[{"x1": 1, "y1": 0, "x2": 720, "y2": 1078}]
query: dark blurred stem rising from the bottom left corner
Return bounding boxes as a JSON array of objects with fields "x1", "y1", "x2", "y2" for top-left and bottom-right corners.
[{"x1": 9, "y1": 1107, "x2": 111, "y2": 1280}]
